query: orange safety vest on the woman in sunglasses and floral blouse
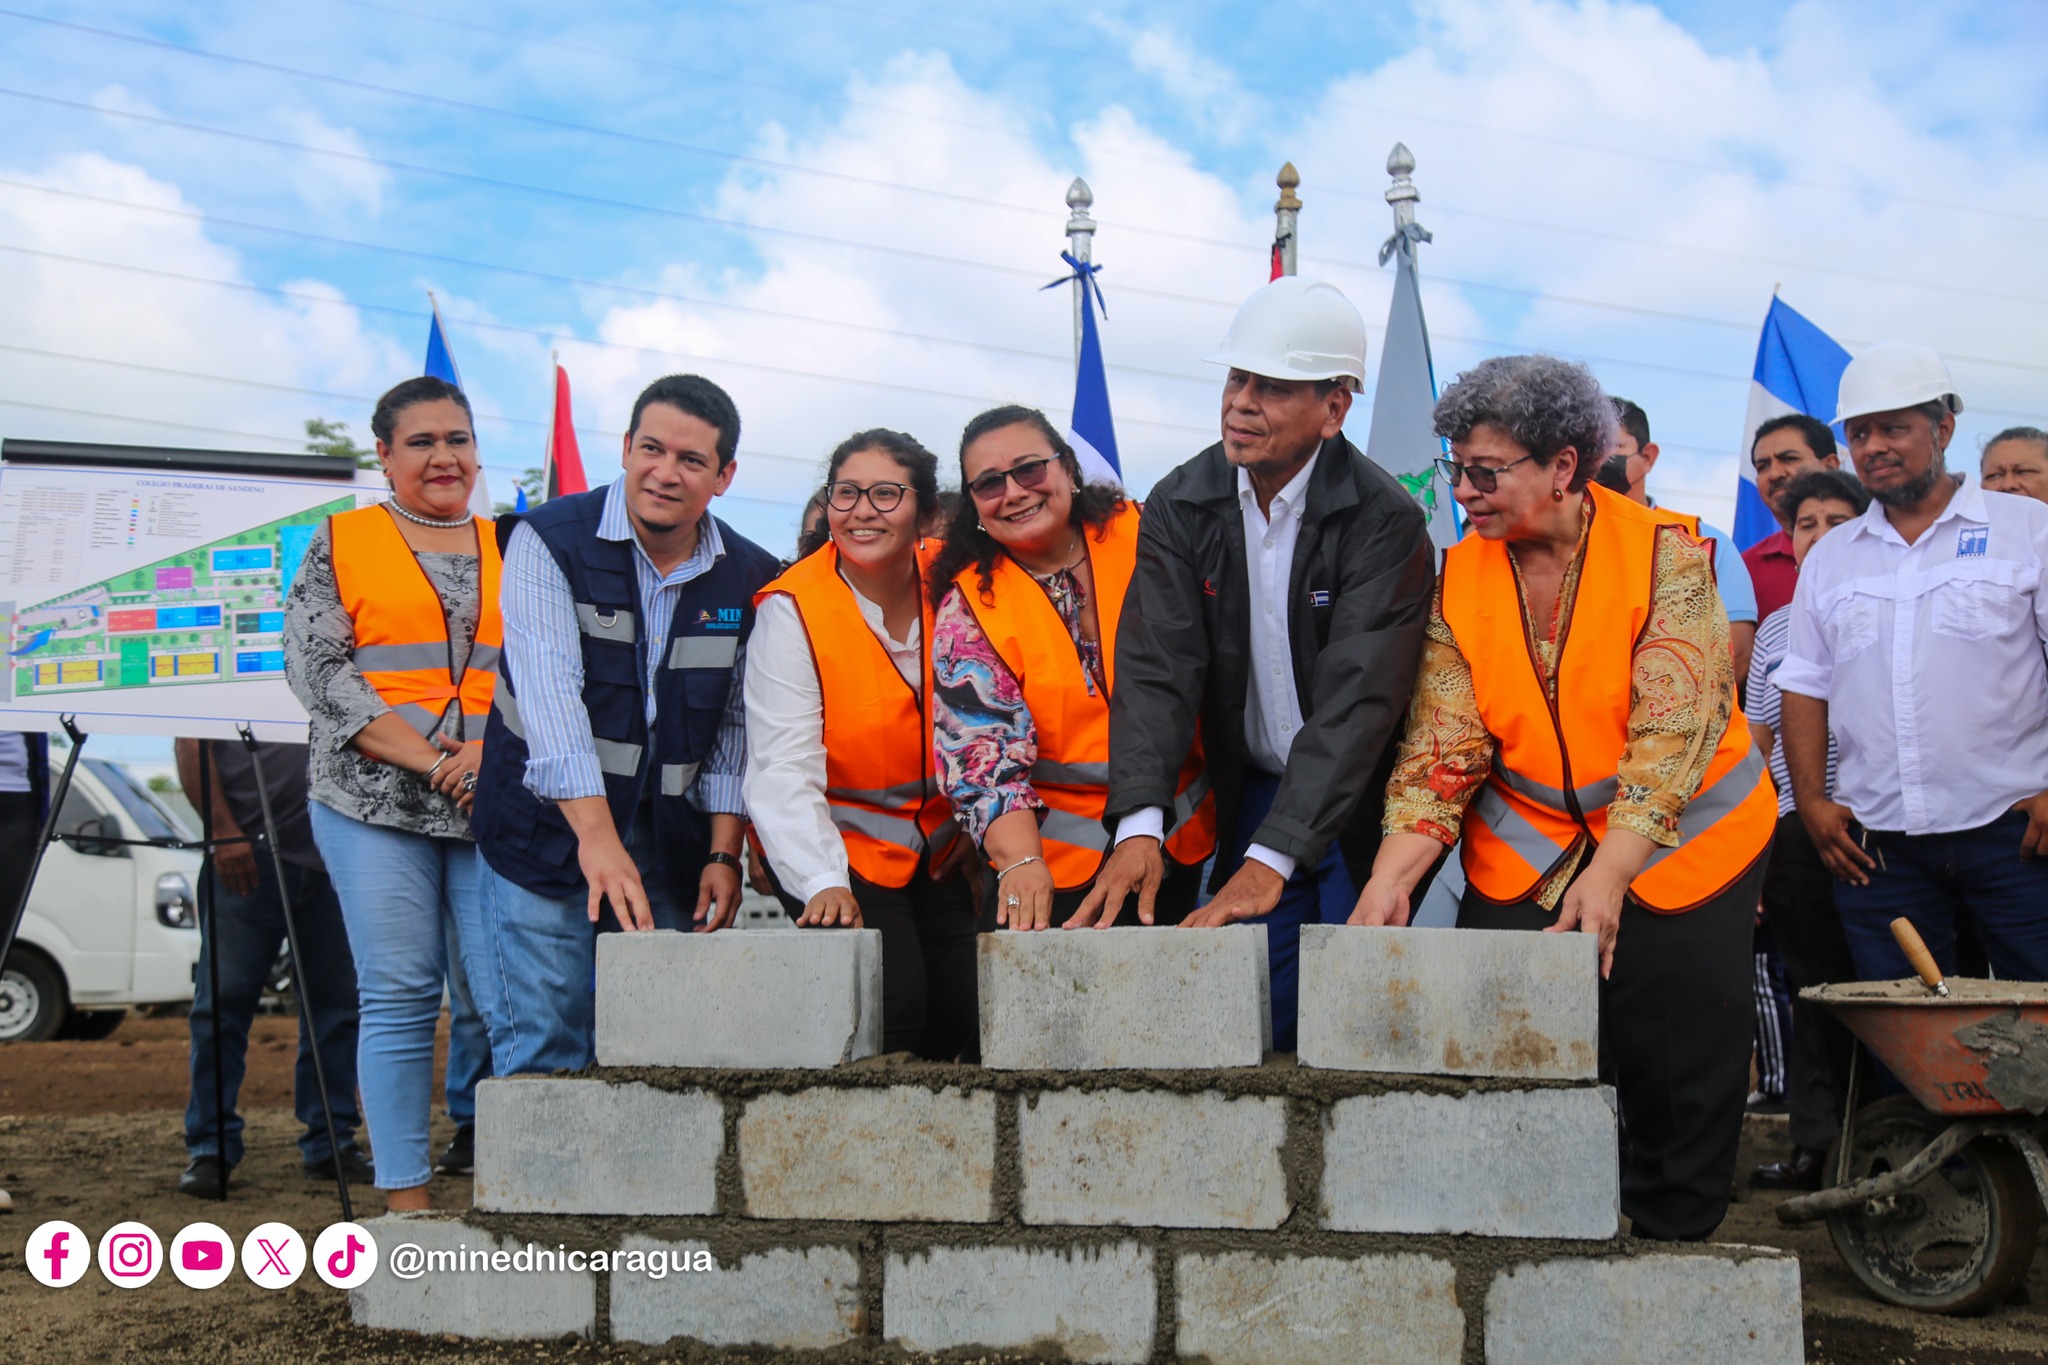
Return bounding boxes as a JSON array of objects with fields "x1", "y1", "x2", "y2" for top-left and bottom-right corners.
[{"x1": 954, "y1": 503, "x2": 1217, "y2": 890}]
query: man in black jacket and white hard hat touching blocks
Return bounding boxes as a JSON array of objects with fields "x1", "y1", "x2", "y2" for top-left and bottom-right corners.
[{"x1": 1067, "y1": 276, "x2": 1436, "y2": 1052}]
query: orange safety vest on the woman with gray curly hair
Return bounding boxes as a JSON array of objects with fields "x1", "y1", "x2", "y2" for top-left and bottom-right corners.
[{"x1": 1444, "y1": 485, "x2": 1778, "y2": 913}]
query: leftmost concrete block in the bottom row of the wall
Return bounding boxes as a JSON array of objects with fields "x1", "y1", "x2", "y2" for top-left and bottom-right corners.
[{"x1": 348, "y1": 1214, "x2": 598, "y2": 1340}]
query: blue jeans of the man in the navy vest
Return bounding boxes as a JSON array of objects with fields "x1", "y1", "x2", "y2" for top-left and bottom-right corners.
[{"x1": 473, "y1": 802, "x2": 696, "y2": 1076}]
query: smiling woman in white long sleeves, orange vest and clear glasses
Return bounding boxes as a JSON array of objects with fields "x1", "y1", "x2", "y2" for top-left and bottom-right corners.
[{"x1": 745, "y1": 430, "x2": 979, "y2": 1060}]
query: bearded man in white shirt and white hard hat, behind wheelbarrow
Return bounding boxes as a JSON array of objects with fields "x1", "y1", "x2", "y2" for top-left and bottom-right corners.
[{"x1": 1778, "y1": 342, "x2": 2048, "y2": 980}]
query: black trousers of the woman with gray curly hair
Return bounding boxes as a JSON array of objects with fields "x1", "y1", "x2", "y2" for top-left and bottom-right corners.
[{"x1": 1458, "y1": 857, "x2": 1763, "y2": 1242}]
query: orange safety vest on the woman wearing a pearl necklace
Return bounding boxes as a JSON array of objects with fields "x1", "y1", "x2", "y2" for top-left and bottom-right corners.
[{"x1": 328, "y1": 508, "x2": 504, "y2": 741}]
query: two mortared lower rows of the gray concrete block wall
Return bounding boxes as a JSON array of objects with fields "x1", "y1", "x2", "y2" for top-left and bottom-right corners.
[{"x1": 364, "y1": 1058, "x2": 1800, "y2": 1365}]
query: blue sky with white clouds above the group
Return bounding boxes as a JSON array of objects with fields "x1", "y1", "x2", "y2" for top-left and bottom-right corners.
[{"x1": 0, "y1": 0, "x2": 2048, "y2": 548}]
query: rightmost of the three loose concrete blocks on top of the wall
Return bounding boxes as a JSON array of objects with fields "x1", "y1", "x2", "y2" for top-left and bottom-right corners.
[{"x1": 1300, "y1": 925, "x2": 1599, "y2": 1081}]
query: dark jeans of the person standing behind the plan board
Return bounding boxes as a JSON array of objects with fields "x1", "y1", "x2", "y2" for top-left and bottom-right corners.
[{"x1": 184, "y1": 847, "x2": 362, "y2": 1166}]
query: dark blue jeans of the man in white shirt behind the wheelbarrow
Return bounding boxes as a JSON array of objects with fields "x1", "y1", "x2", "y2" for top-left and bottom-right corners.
[{"x1": 1835, "y1": 810, "x2": 2048, "y2": 980}]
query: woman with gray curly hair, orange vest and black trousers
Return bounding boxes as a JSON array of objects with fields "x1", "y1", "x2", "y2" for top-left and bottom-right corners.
[{"x1": 1352, "y1": 356, "x2": 1778, "y2": 1240}]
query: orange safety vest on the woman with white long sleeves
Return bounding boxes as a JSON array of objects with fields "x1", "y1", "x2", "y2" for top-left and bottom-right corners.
[{"x1": 754, "y1": 540, "x2": 958, "y2": 886}]
